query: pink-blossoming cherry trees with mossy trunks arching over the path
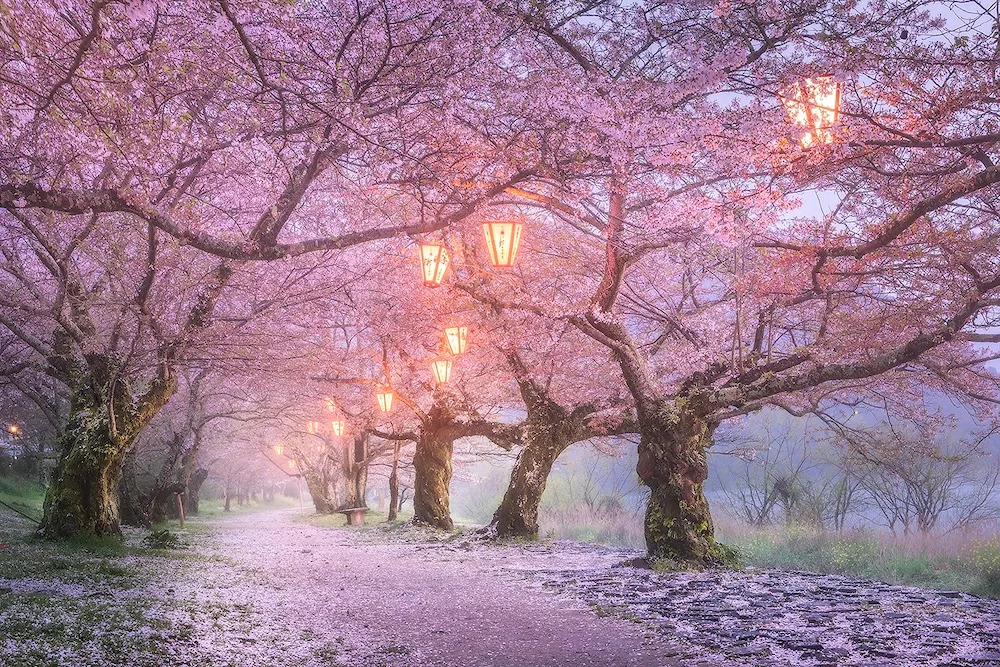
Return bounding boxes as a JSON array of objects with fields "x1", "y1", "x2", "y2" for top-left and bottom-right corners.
[{"x1": 0, "y1": 0, "x2": 1000, "y2": 563}]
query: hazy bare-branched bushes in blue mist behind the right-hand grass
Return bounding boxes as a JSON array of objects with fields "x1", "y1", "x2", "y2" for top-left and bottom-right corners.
[{"x1": 720, "y1": 414, "x2": 1000, "y2": 535}]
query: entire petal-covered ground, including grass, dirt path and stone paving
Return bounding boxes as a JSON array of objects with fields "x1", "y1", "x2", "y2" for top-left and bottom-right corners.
[{"x1": 0, "y1": 511, "x2": 1000, "y2": 666}]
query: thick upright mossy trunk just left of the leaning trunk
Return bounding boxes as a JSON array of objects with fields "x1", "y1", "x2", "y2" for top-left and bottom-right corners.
[{"x1": 413, "y1": 429, "x2": 455, "y2": 530}]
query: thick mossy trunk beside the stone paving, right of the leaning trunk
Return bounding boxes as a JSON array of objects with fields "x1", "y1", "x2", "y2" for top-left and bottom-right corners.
[{"x1": 636, "y1": 409, "x2": 733, "y2": 566}]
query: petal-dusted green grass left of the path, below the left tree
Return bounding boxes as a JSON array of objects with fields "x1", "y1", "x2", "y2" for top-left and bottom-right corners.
[{"x1": 0, "y1": 479, "x2": 203, "y2": 667}]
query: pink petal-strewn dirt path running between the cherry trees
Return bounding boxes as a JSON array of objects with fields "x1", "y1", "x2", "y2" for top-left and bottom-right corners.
[{"x1": 178, "y1": 512, "x2": 678, "y2": 667}]
